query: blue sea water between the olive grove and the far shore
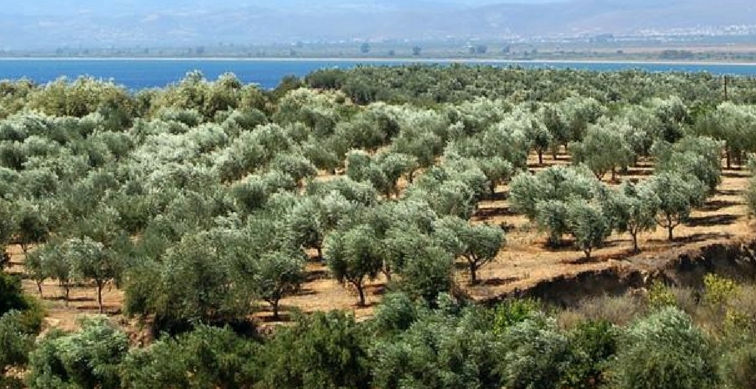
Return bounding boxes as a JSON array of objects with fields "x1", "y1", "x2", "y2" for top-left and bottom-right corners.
[{"x1": 0, "y1": 59, "x2": 756, "y2": 90}]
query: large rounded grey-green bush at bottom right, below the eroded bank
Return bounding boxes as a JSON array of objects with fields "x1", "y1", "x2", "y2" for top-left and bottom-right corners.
[{"x1": 610, "y1": 307, "x2": 719, "y2": 389}]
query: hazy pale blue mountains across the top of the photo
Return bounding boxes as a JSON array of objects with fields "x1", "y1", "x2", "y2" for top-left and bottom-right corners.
[{"x1": 0, "y1": 0, "x2": 756, "y2": 49}]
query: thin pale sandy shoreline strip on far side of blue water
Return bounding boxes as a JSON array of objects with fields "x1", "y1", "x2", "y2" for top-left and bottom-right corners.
[{"x1": 0, "y1": 57, "x2": 756, "y2": 66}]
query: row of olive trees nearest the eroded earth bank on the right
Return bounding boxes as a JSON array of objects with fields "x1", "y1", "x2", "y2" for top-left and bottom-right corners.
[{"x1": 510, "y1": 134, "x2": 722, "y2": 258}]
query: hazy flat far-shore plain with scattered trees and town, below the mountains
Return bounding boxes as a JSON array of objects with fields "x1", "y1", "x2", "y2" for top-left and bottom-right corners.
[{"x1": 5, "y1": 29, "x2": 756, "y2": 62}]
